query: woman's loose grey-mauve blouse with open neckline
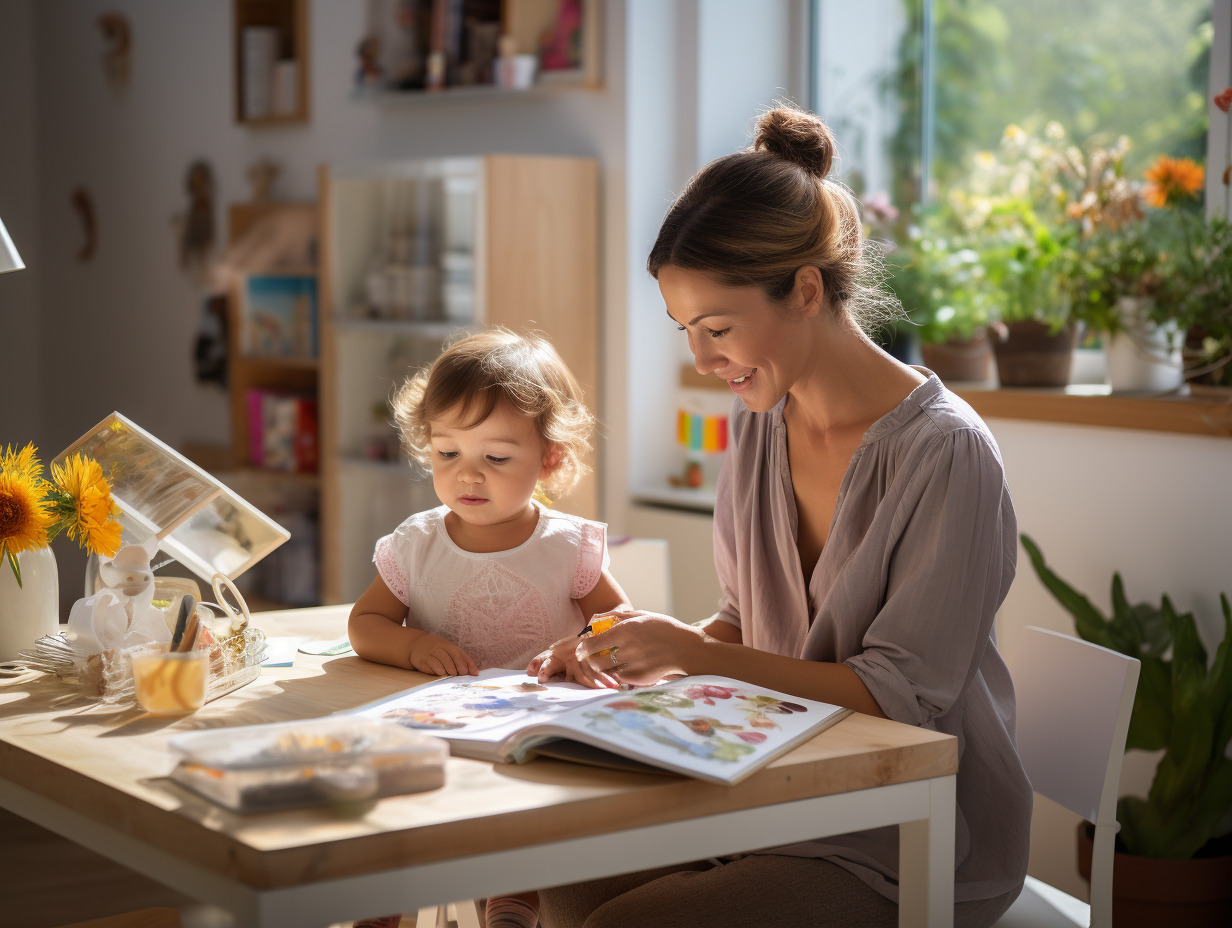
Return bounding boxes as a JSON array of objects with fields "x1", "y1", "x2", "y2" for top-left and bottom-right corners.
[{"x1": 715, "y1": 371, "x2": 1031, "y2": 902}]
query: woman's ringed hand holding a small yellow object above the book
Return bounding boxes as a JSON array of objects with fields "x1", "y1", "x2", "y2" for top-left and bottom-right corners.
[{"x1": 574, "y1": 613, "x2": 708, "y2": 686}]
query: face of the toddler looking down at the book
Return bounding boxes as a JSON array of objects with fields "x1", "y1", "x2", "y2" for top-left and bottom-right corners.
[{"x1": 429, "y1": 403, "x2": 554, "y2": 526}]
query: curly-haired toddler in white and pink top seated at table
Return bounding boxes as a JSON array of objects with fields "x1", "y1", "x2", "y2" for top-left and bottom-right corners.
[{"x1": 347, "y1": 328, "x2": 627, "y2": 928}]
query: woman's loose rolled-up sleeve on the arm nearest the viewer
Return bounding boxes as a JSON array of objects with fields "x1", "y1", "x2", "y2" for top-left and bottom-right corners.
[{"x1": 845, "y1": 429, "x2": 1016, "y2": 725}]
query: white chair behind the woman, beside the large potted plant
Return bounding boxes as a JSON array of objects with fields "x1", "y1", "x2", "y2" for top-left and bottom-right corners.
[{"x1": 997, "y1": 626, "x2": 1140, "y2": 928}]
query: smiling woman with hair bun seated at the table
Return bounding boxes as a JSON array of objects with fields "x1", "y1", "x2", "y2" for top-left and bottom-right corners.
[{"x1": 542, "y1": 108, "x2": 1031, "y2": 928}]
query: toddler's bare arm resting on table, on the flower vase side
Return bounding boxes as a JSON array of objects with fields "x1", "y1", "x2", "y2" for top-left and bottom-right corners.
[{"x1": 346, "y1": 574, "x2": 479, "y2": 677}]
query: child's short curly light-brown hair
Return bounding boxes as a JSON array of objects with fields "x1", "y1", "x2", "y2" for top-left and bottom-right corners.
[{"x1": 392, "y1": 325, "x2": 595, "y2": 499}]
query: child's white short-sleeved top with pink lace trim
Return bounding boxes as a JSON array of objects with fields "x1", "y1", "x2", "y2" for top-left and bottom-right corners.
[{"x1": 372, "y1": 504, "x2": 607, "y2": 670}]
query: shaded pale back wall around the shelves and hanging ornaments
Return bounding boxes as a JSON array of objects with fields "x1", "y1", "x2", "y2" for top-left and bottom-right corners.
[{"x1": 0, "y1": 0, "x2": 626, "y2": 608}]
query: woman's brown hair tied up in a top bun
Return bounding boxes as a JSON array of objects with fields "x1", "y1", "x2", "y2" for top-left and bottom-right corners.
[{"x1": 646, "y1": 106, "x2": 899, "y2": 330}]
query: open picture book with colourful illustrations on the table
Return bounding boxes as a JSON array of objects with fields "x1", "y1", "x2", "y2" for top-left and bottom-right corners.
[{"x1": 352, "y1": 669, "x2": 851, "y2": 785}]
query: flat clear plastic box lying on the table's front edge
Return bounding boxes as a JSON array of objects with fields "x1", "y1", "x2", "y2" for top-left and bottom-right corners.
[{"x1": 170, "y1": 716, "x2": 450, "y2": 812}]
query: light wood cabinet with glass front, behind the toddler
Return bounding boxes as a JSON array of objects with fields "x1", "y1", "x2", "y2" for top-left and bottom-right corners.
[{"x1": 320, "y1": 155, "x2": 599, "y2": 603}]
